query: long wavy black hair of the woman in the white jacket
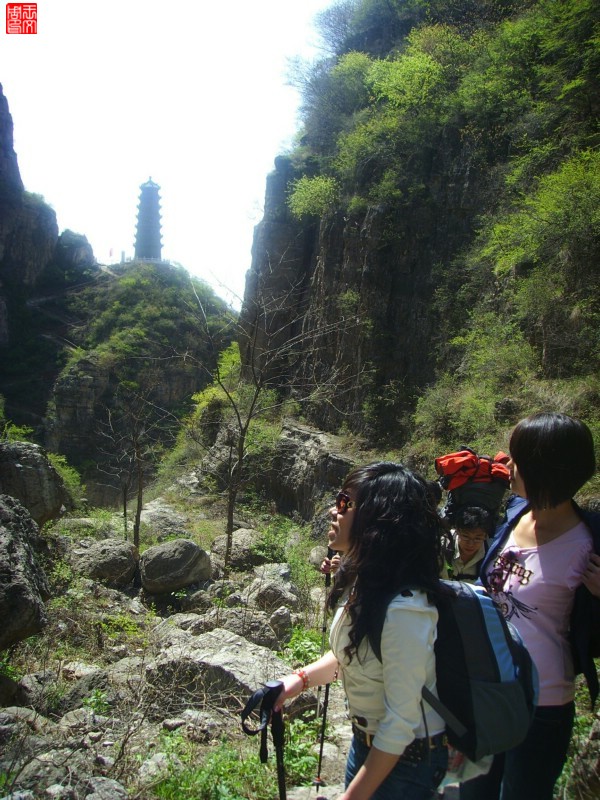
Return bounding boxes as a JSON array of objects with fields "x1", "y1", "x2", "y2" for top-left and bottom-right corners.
[{"x1": 329, "y1": 461, "x2": 443, "y2": 659}]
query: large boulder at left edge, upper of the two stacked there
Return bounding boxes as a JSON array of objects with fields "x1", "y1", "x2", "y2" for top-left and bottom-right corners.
[{"x1": 0, "y1": 442, "x2": 72, "y2": 527}]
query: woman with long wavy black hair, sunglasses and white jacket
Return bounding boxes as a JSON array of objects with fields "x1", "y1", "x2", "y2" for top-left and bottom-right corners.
[{"x1": 276, "y1": 462, "x2": 448, "y2": 800}]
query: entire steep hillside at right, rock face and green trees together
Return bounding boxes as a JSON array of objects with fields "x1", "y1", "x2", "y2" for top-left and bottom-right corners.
[{"x1": 242, "y1": 0, "x2": 600, "y2": 465}]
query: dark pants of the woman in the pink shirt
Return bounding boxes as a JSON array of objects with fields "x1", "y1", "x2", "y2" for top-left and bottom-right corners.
[{"x1": 460, "y1": 703, "x2": 575, "y2": 800}]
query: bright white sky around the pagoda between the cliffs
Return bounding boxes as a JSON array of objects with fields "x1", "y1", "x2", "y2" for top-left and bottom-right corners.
[{"x1": 0, "y1": 0, "x2": 332, "y2": 307}]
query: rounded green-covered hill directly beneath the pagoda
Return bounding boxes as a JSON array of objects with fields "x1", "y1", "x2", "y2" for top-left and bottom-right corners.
[{"x1": 41, "y1": 263, "x2": 232, "y2": 500}]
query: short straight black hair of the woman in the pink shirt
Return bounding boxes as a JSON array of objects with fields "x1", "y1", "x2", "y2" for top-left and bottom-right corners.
[{"x1": 509, "y1": 411, "x2": 596, "y2": 509}]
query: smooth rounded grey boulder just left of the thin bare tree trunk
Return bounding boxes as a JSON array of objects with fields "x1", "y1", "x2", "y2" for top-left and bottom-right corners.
[{"x1": 140, "y1": 539, "x2": 212, "y2": 595}]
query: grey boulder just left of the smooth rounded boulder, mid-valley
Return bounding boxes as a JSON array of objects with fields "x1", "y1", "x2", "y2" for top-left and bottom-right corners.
[{"x1": 71, "y1": 539, "x2": 137, "y2": 587}]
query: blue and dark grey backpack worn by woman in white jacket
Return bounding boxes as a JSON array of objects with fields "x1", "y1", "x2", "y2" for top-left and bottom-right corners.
[{"x1": 374, "y1": 581, "x2": 538, "y2": 761}]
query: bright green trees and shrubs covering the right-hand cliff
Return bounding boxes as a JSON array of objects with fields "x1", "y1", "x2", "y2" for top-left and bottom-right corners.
[{"x1": 289, "y1": 0, "x2": 600, "y2": 456}]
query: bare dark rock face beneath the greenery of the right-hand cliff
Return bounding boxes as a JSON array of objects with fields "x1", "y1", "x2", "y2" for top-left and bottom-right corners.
[{"x1": 242, "y1": 148, "x2": 486, "y2": 438}]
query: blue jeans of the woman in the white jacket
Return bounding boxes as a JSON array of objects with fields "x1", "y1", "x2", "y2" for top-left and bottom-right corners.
[{"x1": 346, "y1": 736, "x2": 448, "y2": 800}]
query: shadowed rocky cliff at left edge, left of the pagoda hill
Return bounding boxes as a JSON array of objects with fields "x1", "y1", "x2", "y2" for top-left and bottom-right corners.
[{"x1": 0, "y1": 86, "x2": 97, "y2": 428}]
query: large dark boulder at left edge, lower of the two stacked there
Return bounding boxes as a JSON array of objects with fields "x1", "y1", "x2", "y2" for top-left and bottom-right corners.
[{"x1": 0, "y1": 495, "x2": 49, "y2": 649}]
